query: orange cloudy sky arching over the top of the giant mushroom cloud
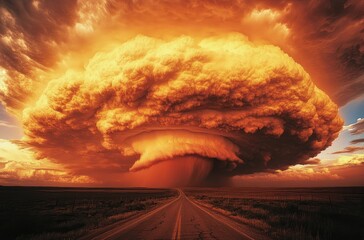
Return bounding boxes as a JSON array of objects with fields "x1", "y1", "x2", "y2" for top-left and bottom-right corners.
[{"x1": 0, "y1": 0, "x2": 364, "y2": 115}]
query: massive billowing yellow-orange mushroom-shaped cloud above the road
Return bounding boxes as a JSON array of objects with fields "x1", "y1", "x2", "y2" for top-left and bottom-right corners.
[{"x1": 23, "y1": 34, "x2": 342, "y2": 185}]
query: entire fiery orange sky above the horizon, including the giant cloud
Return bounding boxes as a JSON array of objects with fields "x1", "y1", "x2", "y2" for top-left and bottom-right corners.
[{"x1": 0, "y1": 0, "x2": 364, "y2": 187}]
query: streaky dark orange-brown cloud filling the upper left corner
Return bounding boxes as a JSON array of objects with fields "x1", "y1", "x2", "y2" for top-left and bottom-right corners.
[{"x1": 0, "y1": 0, "x2": 77, "y2": 109}]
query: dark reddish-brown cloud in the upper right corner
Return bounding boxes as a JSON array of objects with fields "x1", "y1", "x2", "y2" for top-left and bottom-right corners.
[{"x1": 287, "y1": 0, "x2": 364, "y2": 105}]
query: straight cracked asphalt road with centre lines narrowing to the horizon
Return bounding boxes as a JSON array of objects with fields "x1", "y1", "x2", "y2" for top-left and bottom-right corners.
[{"x1": 87, "y1": 189, "x2": 269, "y2": 240}]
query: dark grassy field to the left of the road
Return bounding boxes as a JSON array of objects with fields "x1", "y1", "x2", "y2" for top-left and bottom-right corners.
[{"x1": 0, "y1": 187, "x2": 177, "y2": 240}]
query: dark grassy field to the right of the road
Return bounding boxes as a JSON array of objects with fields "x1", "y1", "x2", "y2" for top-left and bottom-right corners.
[{"x1": 185, "y1": 187, "x2": 364, "y2": 240}]
